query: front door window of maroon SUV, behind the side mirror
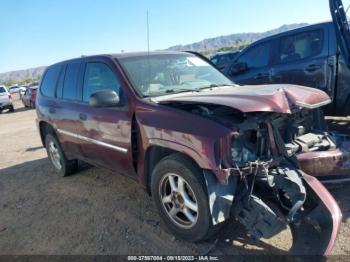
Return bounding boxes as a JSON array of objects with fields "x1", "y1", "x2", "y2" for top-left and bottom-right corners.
[{"x1": 83, "y1": 62, "x2": 120, "y2": 102}]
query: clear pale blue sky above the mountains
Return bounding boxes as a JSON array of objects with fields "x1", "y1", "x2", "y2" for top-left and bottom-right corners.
[{"x1": 0, "y1": 0, "x2": 331, "y2": 72}]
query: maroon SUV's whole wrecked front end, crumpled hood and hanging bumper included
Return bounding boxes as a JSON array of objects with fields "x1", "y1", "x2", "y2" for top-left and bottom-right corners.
[{"x1": 158, "y1": 86, "x2": 342, "y2": 255}]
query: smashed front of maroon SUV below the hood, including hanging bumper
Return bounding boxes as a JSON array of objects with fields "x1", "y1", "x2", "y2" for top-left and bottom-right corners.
[{"x1": 196, "y1": 105, "x2": 342, "y2": 255}]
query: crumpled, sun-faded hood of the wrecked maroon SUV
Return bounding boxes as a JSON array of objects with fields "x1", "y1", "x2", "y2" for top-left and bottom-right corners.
[{"x1": 153, "y1": 84, "x2": 331, "y2": 114}]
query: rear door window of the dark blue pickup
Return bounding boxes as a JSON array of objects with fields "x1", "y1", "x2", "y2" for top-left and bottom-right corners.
[{"x1": 278, "y1": 30, "x2": 323, "y2": 63}]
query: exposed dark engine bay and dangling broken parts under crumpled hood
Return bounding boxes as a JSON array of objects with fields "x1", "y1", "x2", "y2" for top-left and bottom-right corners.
[{"x1": 165, "y1": 103, "x2": 342, "y2": 254}]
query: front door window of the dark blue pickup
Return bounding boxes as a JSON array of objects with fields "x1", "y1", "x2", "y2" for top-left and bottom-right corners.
[{"x1": 237, "y1": 42, "x2": 271, "y2": 69}]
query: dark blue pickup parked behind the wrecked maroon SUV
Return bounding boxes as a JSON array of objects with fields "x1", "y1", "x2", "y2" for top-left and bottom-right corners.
[{"x1": 225, "y1": 22, "x2": 350, "y2": 115}]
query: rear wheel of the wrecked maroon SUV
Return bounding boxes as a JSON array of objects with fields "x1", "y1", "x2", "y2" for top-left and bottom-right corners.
[{"x1": 45, "y1": 133, "x2": 78, "y2": 177}]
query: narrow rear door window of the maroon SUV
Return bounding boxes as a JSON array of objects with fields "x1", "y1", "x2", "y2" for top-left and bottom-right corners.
[{"x1": 62, "y1": 62, "x2": 80, "y2": 100}]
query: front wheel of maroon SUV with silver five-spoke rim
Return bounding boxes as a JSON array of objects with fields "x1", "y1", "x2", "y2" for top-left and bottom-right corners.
[{"x1": 151, "y1": 154, "x2": 217, "y2": 242}]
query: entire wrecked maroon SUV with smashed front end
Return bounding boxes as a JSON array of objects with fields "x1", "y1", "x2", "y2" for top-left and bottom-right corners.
[{"x1": 36, "y1": 52, "x2": 341, "y2": 254}]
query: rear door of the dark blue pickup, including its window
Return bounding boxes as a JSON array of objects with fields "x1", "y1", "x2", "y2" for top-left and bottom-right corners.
[{"x1": 271, "y1": 24, "x2": 334, "y2": 97}]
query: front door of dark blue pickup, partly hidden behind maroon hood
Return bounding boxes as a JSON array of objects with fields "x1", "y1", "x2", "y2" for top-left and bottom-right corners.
[{"x1": 231, "y1": 40, "x2": 272, "y2": 85}]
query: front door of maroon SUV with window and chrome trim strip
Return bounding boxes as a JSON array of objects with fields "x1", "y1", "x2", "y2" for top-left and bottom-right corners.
[{"x1": 78, "y1": 57, "x2": 134, "y2": 174}]
